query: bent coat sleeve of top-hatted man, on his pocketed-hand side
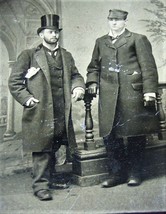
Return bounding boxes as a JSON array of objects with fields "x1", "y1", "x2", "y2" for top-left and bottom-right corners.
[{"x1": 8, "y1": 50, "x2": 32, "y2": 105}]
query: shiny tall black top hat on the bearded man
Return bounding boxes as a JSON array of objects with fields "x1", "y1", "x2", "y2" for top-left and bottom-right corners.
[{"x1": 37, "y1": 14, "x2": 62, "y2": 34}]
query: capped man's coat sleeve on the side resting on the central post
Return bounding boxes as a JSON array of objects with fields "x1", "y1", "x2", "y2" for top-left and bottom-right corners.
[{"x1": 86, "y1": 39, "x2": 100, "y2": 85}]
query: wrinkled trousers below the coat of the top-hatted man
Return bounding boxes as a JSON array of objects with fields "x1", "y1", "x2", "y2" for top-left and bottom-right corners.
[{"x1": 32, "y1": 144, "x2": 61, "y2": 193}]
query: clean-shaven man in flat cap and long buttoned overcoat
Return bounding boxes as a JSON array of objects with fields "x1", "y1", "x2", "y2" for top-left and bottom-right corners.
[{"x1": 86, "y1": 9, "x2": 159, "y2": 187}]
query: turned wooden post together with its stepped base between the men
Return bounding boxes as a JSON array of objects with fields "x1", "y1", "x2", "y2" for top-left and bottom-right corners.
[{"x1": 72, "y1": 90, "x2": 109, "y2": 186}]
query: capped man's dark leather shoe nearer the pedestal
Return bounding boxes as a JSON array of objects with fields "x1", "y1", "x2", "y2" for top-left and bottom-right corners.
[{"x1": 101, "y1": 176, "x2": 126, "y2": 188}]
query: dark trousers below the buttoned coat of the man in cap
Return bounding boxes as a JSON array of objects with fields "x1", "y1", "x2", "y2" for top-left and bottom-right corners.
[{"x1": 104, "y1": 135, "x2": 146, "y2": 178}]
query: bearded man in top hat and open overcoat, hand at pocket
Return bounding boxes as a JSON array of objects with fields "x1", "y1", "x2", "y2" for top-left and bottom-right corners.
[{"x1": 9, "y1": 14, "x2": 85, "y2": 200}]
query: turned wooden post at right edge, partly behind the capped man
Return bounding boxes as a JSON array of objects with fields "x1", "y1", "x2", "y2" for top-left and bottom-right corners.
[{"x1": 157, "y1": 85, "x2": 166, "y2": 140}]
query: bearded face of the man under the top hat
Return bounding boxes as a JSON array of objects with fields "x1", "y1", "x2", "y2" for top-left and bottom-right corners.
[{"x1": 39, "y1": 29, "x2": 59, "y2": 44}]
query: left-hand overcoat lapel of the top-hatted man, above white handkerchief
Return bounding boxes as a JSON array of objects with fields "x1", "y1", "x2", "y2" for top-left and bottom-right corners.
[{"x1": 35, "y1": 48, "x2": 50, "y2": 84}]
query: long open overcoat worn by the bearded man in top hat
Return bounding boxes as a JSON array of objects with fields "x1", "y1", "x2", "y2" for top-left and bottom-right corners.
[{"x1": 9, "y1": 46, "x2": 85, "y2": 152}]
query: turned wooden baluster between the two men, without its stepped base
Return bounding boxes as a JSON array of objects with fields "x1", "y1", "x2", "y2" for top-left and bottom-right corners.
[{"x1": 84, "y1": 90, "x2": 96, "y2": 150}]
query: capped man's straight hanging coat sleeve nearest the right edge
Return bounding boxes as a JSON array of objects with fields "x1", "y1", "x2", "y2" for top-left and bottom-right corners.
[{"x1": 135, "y1": 35, "x2": 158, "y2": 93}]
